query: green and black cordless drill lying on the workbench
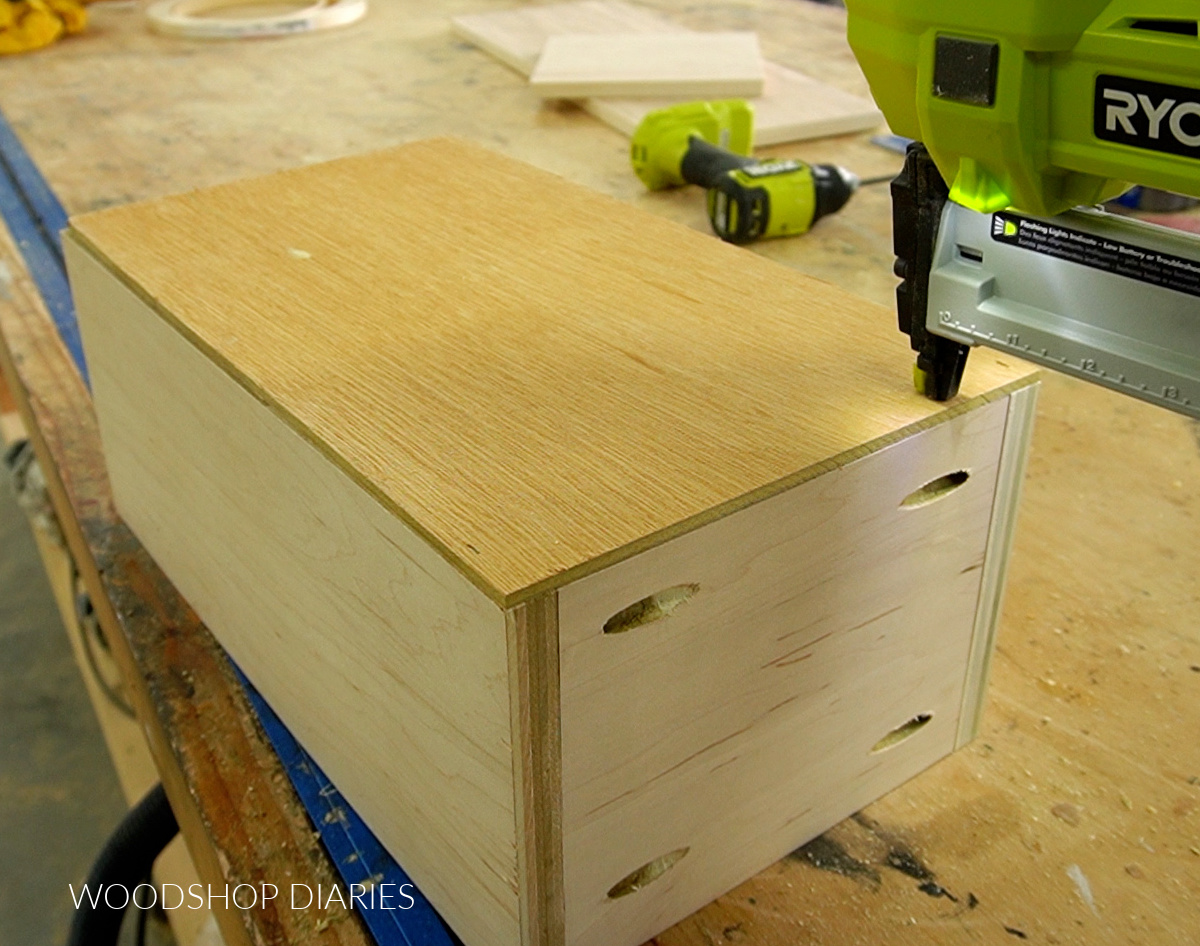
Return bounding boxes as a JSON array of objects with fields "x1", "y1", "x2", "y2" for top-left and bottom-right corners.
[{"x1": 630, "y1": 98, "x2": 859, "y2": 244}]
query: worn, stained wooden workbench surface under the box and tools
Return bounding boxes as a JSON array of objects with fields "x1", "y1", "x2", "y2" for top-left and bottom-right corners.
[{"x1": 0, "y1": 0, "x2": 1200, "y2": 946}]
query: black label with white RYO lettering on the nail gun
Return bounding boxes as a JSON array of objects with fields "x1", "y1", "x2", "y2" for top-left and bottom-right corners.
[{"x1": 1093, "y1": 76, "x2": 1200, "y2": 158}]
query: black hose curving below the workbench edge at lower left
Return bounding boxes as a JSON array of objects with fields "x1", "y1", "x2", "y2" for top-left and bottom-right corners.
[{"x1": 67, "y1": 783, "x2": 179, "y2": 946}]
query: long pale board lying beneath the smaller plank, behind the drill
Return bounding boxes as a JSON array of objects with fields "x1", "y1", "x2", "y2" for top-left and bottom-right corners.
[{"x1": 452, "y1": 0, "x2": 883, "y2": 145}]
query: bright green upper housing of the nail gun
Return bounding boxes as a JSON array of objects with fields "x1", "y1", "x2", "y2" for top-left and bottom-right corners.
[{"x1": 846, "y1": 0, "x2": 1200, "y2": 216}]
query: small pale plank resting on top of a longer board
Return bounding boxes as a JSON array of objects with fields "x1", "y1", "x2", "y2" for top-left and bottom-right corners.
[{"x1": 529, "y1": 31, "x2": 763, "y2": 98}]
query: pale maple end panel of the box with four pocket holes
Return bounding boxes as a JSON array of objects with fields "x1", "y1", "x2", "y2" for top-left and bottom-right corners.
[{"x1": 559, "y1": 397, "x2": 1008, "y2": 946}]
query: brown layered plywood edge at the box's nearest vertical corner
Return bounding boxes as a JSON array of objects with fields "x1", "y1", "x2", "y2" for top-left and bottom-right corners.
[{"x1": 505, "y1": 592, "x2": 565, "y2": 946}]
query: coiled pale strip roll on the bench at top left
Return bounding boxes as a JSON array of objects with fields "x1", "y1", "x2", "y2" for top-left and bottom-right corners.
[{"x1": 146, "y1": 0, "x2": 367, "y2": 40}]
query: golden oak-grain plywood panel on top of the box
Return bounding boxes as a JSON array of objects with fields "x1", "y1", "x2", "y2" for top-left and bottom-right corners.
[{"x1": 73, "y1": 139, "x2": 1028, "y2": 603}]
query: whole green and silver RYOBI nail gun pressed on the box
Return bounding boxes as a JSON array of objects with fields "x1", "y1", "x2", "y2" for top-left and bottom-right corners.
[{"x1": 846, "y1": 0, "x2": 1200, "y2": 418}]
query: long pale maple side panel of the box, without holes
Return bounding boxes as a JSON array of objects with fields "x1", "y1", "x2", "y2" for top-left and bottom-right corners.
[{"x1": 65, "y1": 235, "x2": 521, "y2": 946}]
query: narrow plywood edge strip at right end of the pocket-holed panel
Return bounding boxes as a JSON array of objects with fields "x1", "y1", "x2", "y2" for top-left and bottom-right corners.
[{"x1": 954, "y1": 384, "x2": 1038, "y2": 749}]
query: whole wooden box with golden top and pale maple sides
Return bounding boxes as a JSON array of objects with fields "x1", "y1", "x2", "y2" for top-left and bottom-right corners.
[{"x1": 66, "y1": 140, "x2": 1036, "y2": 946}]
